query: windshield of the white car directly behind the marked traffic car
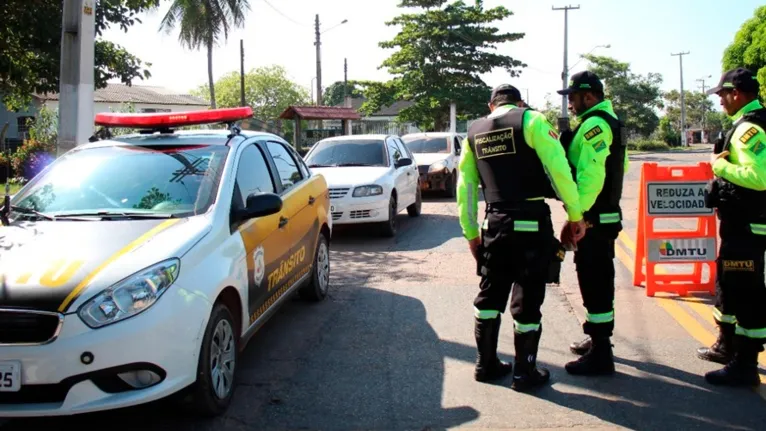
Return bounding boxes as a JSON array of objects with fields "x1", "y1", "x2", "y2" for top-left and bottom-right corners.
[{"x1": 306, "y1": 139, "x2": 388, "y2": 167}]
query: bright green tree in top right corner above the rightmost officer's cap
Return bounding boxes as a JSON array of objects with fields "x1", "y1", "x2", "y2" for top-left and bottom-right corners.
[{"x1": 722, "y1": 6, "x2": 766, "y2": 99}]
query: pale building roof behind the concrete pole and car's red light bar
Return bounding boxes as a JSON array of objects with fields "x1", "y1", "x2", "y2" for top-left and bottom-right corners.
[{"x1": 35, "y1": 83, "x2": 210, "y2": 107}]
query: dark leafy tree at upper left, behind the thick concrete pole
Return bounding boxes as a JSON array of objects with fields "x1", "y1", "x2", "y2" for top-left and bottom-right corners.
[{"x1": 0, "y1": 0, "x2": 160, "y2": 110}]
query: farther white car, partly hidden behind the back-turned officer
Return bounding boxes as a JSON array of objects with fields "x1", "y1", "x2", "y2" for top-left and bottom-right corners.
[{"x1": 402, "y1": 132, "x2": 462, "y2": 197}]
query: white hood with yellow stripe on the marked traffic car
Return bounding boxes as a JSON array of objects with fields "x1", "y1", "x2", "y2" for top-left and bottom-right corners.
[{"x1": 0, "y1": 216, "x2": 210, "y2": 312}]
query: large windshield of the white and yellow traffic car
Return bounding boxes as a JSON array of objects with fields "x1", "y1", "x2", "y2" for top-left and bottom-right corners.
[{"x1": 13, "y1": 139, "x2": 229, "y2": 217}]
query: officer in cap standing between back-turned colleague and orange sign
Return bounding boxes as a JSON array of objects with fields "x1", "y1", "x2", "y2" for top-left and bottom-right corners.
[{"x1": 558, "y1": 71, "x2": 628, "y2": 375}]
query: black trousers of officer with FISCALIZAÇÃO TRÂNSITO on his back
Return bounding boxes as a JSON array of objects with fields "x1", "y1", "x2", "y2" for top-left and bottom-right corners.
[{"x1": 474, "y1": 200, "x2": 556, "y2": 333}]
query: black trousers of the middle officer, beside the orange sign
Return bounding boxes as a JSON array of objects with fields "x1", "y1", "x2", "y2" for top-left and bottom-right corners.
[{"x1": 574, "y1": 213, "x2": 622, "y2": 338}]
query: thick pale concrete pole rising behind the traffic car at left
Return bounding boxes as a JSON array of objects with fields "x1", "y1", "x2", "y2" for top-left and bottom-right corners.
[{"x1": 57, "y1": 0, "x2": 96, "y2": 155}]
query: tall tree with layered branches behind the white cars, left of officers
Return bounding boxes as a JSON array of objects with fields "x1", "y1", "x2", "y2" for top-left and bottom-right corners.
[{"x1": 361, "y1": 0, "x2": 526, "y2": 130}]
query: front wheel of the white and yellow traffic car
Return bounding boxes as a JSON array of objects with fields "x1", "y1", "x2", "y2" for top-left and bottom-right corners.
[{"x1": 192, "y1": 303, "x2": 239, "y2": 416}]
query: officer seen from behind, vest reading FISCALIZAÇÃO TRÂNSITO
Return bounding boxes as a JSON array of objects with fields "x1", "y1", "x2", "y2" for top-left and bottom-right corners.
[{"x1": 457, "y1": 85, "x2": 585, "y2": 390}]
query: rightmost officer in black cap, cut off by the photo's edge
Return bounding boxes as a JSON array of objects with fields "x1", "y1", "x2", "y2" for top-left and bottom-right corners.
[{"x1": 698, "y1": 68, "x2": 766, "y2": 386}]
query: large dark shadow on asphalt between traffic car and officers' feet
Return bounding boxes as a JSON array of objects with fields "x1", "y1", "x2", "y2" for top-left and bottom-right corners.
[{"x1": 0, "y1": 288, "x2": 479, "y2": 431}]
